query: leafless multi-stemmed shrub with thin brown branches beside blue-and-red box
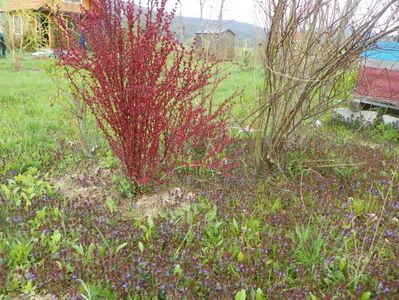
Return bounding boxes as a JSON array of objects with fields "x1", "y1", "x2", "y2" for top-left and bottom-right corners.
[{"x1": 252, "y1": 0, "x2": 399, "y2": 166}]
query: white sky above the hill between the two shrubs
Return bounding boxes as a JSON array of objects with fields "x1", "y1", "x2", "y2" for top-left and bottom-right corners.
[{"x1": 169, "y1": 0, "x2": 254, "y2": 24}]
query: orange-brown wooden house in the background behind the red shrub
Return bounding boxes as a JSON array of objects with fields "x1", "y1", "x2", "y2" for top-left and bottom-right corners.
[{"x1": 0, "y1": 0, "x2": 91, "y2": 48}]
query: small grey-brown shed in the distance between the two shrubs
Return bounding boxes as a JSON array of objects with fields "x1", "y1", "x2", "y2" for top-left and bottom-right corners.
[{"x1": 195, "y1": 29, "x2": 236, "y2": 60}]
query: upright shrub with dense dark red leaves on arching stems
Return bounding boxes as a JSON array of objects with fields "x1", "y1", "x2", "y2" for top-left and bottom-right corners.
[{"x1": 55, "y1": 0, "x2": 233, "y2": 184}]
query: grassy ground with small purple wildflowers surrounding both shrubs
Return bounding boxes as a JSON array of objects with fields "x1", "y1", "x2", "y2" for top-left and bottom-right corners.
[{"x1": 0, "y1": 55, "x2": 399, "y2": 300}]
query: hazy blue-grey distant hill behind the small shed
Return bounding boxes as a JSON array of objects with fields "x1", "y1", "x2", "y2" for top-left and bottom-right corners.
[{"x1": 172, "y1": 16, "x2": 262, "y2": 46}]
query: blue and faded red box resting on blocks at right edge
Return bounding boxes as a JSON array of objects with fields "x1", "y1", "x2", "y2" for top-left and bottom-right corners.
[{"x1": 355, "y1": 42, "x2": 399, "y2": 110}]
